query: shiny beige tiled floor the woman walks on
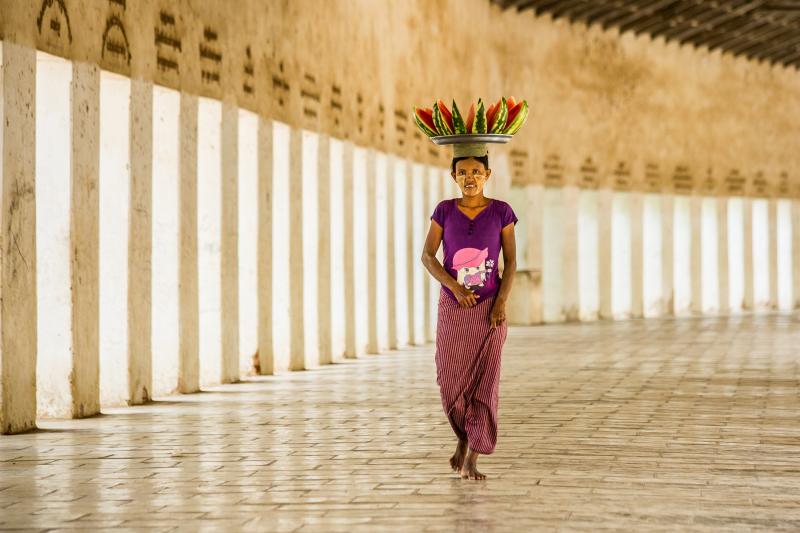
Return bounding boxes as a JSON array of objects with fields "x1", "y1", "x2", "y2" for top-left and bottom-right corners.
[{"x1": 0, "y1": 314, "x2": 800, "y2": 532}]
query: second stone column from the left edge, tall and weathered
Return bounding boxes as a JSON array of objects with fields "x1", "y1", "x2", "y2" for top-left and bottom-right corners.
[{"x1": 70, "y1": 62, "x2": 100, "y2": 418}]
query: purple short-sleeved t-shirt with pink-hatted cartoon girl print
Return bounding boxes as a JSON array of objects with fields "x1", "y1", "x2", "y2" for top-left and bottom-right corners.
[{"x1": 431, "y1": 198, "x2": 517, "y2": 301}]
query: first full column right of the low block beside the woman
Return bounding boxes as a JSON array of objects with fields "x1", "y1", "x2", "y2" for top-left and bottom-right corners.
[{"x1": 561, "y1": 185, "x2": 580, "y2": 322}]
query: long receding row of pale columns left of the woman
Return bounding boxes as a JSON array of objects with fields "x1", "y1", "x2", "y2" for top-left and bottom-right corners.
[{"x1": 0, "y1": 43, "x2": 455, "y2": 433}]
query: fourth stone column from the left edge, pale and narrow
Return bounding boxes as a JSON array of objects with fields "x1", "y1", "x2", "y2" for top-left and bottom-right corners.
[{"x1": 178, "y1": 93, "x2": 200, "y2": 393}]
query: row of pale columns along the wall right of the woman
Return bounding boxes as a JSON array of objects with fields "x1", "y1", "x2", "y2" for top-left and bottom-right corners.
[{"x1": 521, "y1": 185, "x2": 800, "y2": 323}]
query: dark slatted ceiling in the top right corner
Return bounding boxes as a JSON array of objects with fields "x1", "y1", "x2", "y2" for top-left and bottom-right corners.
[{"x1": 491, "y1": 0, "x2": 800, "y2": 69}]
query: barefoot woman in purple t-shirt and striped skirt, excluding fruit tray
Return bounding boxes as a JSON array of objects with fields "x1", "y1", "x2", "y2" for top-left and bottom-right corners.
[{"x1": 422, "y1": 143, "x2": 517, "y2": 479}]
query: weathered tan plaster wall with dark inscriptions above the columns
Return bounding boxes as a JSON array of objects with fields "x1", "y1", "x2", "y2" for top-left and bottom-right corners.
[{"x1": 0, "y1": 0, "x2": 800, "y2": 196}]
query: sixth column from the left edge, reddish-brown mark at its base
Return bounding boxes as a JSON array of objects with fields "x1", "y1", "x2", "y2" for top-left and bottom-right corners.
[{"x1": 257, "y1": 117, "x2": 275, "y2": 374}]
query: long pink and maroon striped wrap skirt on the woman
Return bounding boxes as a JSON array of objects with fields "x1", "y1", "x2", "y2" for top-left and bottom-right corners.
[{"x1": 436, "y1": 288, "x2": 508, "y2": 454}]
